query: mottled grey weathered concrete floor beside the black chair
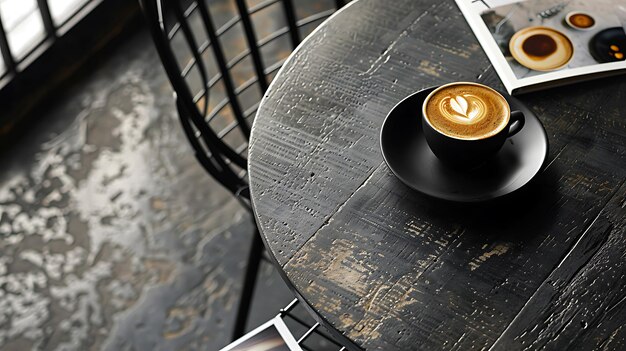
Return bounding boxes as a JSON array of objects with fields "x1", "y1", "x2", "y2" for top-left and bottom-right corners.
[{"x1": 0, "y1": 4, "x2": 342, "y2": 350}]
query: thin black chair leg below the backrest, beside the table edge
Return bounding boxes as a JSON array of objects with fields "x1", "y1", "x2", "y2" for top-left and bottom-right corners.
[{"x1": 232, "y1": 229, "x2": 264, "y2": 341}]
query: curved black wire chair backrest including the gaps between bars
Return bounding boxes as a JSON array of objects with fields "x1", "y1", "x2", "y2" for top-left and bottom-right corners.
[{"x1": 139, "y1": 0, "x2": 344, "y2": 198}]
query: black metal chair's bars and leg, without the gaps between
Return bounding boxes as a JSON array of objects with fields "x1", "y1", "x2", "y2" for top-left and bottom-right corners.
[{"x1": 139, "y1": 0, "x2": 344, "y2": 339}]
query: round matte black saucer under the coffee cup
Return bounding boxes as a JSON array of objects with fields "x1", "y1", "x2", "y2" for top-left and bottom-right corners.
[{"x1": 380, "y1": 87, "x2": 548, "y2": 202}]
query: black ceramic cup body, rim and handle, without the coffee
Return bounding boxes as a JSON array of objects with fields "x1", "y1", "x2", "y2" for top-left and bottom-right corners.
[{"x1": 421, "y1": 82, "x2": 524, "y2": 170}]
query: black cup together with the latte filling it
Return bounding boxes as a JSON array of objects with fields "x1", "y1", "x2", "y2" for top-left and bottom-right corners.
[{"x1": 422, "y1": 82, "x2": 524, "y2": 168}]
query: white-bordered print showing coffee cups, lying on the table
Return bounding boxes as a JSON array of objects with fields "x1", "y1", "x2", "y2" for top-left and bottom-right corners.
[{"x1": 456, "y1": 0, "x2": 626, "y2": 95}]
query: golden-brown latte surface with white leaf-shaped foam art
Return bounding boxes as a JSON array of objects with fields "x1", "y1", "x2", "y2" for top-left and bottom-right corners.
[{"x1": 424, "y1": 83, "x2": 510, "y2": 140}]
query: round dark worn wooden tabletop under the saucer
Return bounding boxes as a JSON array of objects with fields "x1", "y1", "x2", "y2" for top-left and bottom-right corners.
[{"x1": 249, "y1": 0, "x2": 626, "y2": 351}]
